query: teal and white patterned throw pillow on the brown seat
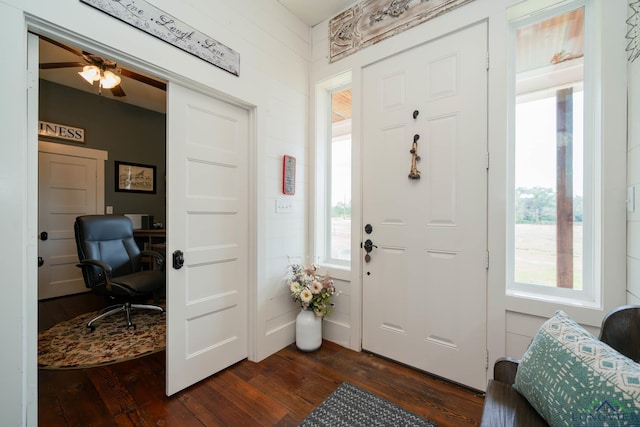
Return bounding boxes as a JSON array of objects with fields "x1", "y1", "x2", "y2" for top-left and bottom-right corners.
[{"x1": 513, "y1": 310, "x2": 640, "y2": 426}]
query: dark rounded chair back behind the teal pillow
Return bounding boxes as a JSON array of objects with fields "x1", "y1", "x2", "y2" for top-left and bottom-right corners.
[{"x1": 599, "y1": 305, "x2": 640, "y2": 362}]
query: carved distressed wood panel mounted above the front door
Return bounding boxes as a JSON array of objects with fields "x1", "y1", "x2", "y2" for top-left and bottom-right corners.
[{"x1": 329, "y1": 0, "x2": 473, "y2": 62}]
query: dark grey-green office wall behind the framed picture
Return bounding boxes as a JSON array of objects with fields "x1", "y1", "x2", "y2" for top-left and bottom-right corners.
[{"x1": 39, "y1": 80, "x2": 166, "y2": 224}]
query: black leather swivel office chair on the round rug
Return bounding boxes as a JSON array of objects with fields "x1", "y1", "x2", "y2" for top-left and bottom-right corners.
[{"x1": 74, "y1": 215, "x2": 166, "y2": 331}]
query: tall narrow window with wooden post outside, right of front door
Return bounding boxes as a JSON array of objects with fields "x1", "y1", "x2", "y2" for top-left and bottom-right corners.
[{"x1": 508, "y1": 1, "x2": 598, "y2": 305}]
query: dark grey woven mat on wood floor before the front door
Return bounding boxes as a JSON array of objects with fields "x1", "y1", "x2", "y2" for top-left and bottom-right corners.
[{"x1": 300, "y1": 382, "x2": 437, "y2": 427}]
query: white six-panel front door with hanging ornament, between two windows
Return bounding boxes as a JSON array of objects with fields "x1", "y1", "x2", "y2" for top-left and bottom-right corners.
[{"x1": 362, "y1": 23, "x2": 488, "y2": 390}]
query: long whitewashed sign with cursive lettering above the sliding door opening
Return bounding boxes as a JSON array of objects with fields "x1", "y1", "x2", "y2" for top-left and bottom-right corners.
[{"x1": 80, "y1": 0, "x2": 240, "y2": 76}]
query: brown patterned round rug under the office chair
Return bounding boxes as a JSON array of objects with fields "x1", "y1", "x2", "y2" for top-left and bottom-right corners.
[{"x1": 38, "y1": 309, "x2": 166, "y2": 369}]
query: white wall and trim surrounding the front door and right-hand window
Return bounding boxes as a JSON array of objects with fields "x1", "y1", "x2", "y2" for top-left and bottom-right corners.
[{"x1": 310, "y1": 0, "x2": 628, "y2": 372}]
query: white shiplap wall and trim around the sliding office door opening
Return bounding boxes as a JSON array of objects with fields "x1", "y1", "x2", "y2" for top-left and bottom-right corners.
[{"x1": 0, "y1": 0, "x2": 310, "y2": 426}]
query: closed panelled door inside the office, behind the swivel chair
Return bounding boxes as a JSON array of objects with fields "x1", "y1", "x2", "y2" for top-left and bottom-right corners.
[{"x1": 38, "y1": 142, "x2": 107, "y2": 299}]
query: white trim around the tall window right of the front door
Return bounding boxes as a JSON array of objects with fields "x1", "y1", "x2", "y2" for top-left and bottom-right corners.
[{"x1": 505, "y1": 0, "x2": 627, "y2": 326}]
